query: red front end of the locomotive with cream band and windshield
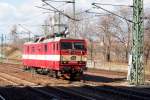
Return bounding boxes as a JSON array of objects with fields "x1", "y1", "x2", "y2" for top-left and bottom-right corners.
[{"x1": 60, "y1": 40, "x2": 87, "y2": 79}]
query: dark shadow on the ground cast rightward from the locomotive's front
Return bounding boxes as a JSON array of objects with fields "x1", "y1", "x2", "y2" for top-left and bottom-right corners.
[{"x1": 83, "y1": 74, "x2": 126, "y2": 83}]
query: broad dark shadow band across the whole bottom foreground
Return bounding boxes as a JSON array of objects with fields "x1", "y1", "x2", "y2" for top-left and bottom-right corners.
[{"x1": 0, "y1": 85, "x2": 150, "y2": 100}]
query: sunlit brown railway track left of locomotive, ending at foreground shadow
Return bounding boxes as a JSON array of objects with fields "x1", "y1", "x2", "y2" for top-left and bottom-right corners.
[{"x1": 0, "y1": 64, "x2": 70, "y2": 86}]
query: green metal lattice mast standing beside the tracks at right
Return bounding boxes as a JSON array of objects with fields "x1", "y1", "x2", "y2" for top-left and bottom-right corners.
[{"x1": 130, "y1": 0, "x2": 144, "y2": 85}]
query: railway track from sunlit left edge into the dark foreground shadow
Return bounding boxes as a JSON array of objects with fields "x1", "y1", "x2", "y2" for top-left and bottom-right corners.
[{"x1": 0, "y1": 72, "x2": 95, "y2": 100}]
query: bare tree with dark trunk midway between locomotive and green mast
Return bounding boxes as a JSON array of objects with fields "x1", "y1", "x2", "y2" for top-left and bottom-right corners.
[{"x1": 99, "y1": 15, "x2": 117, "y2": 62}]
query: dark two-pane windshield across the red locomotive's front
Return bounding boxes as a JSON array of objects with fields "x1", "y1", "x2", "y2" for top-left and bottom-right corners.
[{"x1": 61, "y1": 42, "x2": 85, "y2": 50}]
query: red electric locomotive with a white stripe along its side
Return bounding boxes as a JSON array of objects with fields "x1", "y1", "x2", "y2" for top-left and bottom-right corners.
[{"x1": 22, "y1": 36, "x2": 87, "y2": 79}]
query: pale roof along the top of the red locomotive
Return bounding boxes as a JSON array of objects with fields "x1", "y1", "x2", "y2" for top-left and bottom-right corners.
[{"x1": 24, "y1": 37, "x2": 83, "y2": 44}]
